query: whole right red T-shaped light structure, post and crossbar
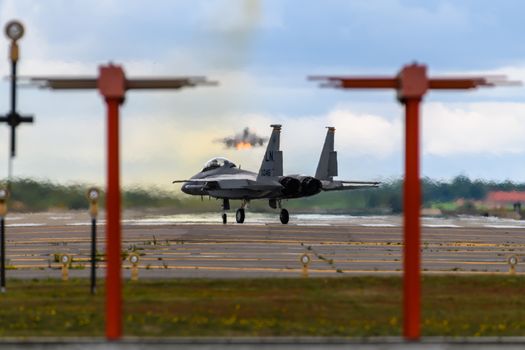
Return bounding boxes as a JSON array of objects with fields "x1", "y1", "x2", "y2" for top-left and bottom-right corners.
[{"x1": 311, "y1": 64, "x2": 508, "y2": 340}]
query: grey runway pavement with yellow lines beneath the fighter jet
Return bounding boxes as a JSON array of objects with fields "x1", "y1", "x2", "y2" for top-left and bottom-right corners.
[{"x1": 1, "y1": 213, "x2": 525, "y2": 278}]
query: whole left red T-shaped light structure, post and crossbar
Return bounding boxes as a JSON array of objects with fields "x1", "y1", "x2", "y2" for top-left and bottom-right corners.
[{"x1": 30, "y1": 63, "x2": 217, "y2": 340}]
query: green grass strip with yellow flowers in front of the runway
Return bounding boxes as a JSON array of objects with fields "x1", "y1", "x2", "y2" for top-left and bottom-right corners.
[{"x1": 0, "y1": 276, "x2": 525, "y2": 337}]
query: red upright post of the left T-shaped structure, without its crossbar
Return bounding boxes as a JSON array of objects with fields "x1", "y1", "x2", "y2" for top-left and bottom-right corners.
[{"x1": 106, "y1": 98, "x2": 122, "y2": 340}]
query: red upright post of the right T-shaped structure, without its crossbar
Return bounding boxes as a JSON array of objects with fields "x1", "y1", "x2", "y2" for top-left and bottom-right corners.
[{"x1": 403, "y1": 97, "x2": 421, "y2": 340}]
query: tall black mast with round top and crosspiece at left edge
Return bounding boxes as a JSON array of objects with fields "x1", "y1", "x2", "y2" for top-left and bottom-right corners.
[{"x1": 0, "y1": 21, "x2": 33, "y2": 184}]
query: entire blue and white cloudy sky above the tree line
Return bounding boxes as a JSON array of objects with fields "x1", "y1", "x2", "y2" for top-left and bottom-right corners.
[{"x1": 0, "y1": 0, "x2": 525, "y2": 189}]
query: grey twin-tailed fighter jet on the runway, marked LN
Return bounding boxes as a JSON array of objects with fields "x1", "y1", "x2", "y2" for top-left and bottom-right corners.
[{"x1": 173, "y1": 125, "x2": 380, "y2": 224}]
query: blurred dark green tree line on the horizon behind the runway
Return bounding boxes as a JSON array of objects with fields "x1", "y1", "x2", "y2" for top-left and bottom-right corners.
[{"x1": 4, "y1": 175, "x2": 525, "y2": 213}]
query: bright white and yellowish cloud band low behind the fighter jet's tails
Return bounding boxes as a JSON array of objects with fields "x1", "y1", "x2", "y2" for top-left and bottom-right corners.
[{"x1": 4, "y1": 97, "x2": 525, "y2": 188}]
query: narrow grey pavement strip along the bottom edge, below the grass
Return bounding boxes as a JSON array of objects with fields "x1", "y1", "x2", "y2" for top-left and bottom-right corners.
[{"x1": 0, "y1": 337, "x2": 525, "y2": 350}]
